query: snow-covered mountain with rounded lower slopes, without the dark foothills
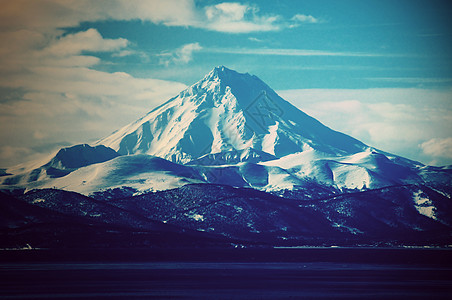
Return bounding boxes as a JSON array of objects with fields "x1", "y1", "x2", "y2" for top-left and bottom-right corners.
[{"x1": 2, "y1": 66, "x2": 452, "y2": 194}]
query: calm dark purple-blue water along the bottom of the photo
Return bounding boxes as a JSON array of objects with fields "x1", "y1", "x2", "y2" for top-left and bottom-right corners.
[{"x1": 0, "y1": 248, "x2": 452, "y2": 299}]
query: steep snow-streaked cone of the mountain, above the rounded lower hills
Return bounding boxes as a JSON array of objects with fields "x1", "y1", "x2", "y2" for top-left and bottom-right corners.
[{"x1": 98, "y1": 66, "x2": 368, "y2": 163}]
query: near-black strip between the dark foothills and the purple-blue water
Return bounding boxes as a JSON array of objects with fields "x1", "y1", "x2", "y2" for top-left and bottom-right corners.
[{"x1": 0, "y1": 247, "x2": 452, "y2": 267}]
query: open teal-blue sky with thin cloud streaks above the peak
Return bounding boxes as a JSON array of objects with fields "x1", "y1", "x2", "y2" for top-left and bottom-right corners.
[{"x1": 90, "y1": 1, "x2": 452, "y2": 89}]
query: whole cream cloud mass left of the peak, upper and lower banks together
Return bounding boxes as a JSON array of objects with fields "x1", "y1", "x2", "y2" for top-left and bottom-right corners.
[{"x1": 0, "y1": 16, "x2": 186, "y2": 167}]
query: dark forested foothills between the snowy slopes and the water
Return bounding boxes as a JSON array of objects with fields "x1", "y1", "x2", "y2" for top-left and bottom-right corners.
[{"x1": 0, "y1": 184, "x2": 452, "y2": 248}]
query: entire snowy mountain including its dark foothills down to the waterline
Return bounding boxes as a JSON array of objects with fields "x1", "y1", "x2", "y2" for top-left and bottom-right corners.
[{"x1": 0, "y1": 67, "x2": 452, "y2": 245}]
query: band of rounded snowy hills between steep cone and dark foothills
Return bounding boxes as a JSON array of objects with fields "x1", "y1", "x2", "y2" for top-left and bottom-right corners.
[{"x1": 4, "y1": 148, "x2": 450, "y2": 197}]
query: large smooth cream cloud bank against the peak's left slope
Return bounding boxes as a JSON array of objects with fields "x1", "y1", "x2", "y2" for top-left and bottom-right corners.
[{"x1": 0, "y1": 67, "x2": 185, "y2": 166}]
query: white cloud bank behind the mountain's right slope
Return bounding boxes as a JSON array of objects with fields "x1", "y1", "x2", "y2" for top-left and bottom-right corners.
[{"x1": 279, "y1": 88, "x2": 452, "y2": 165}]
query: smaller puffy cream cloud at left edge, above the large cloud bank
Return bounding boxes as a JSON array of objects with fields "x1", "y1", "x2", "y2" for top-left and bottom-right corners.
[{"x1": 0, "y1": 29, "x2": 125, "y2": 77}]
